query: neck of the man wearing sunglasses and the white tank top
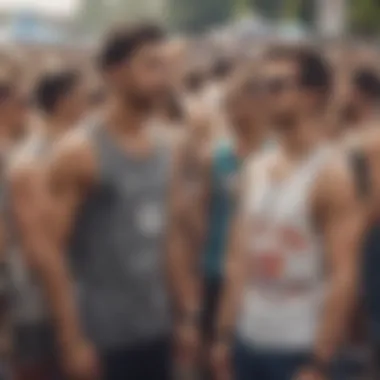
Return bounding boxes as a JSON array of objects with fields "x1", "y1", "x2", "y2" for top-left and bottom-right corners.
[{"x1": 281, "y1": 121, "x2": 319, "y2": 160}]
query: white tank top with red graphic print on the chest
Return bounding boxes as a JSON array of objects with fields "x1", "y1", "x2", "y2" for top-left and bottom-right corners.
[{"x1": 238, "y1": 148, "x2": 329, "y2": 350}]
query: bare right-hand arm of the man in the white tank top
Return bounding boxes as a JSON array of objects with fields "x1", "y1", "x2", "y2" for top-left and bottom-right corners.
[{"x1": 315, "y1": 157, "x2": 366, "y2": 362}]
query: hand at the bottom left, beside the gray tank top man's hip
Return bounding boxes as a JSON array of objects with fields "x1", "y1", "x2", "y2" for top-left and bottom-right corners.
[{"x1": 62, "y1": 340, "x2": 101, "y2": 380}]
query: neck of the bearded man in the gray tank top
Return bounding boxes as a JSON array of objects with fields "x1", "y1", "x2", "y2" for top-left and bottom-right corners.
[{"x1": 106, "y1": 98, "x2": 146, "y2": 134}]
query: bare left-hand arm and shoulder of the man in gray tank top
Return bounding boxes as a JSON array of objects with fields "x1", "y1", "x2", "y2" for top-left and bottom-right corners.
[{"x1": 11, "y1": 136, "x2": 93, "y2": 348}]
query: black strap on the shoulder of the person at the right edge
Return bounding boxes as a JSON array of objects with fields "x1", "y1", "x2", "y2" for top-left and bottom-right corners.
[{"x1": 349, "y1": 149, "x2": 372, "y2": 199}]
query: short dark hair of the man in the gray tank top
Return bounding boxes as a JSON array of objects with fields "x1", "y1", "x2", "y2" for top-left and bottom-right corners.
[{"x1": 98, "y1": 24, "x2": 165, "y2": 70}]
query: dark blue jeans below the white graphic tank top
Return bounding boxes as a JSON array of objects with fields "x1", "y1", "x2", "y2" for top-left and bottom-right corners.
[{"x1": 233, "y1": 342, "x2": 310, "y2": 380}]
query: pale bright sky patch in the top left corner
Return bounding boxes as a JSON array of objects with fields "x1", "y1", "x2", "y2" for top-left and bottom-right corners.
[{"x1": 0, "y1": 0, "x2": 80, "y2": 15}]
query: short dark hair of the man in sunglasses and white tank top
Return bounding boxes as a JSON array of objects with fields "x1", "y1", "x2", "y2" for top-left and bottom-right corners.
[{"x1": 267, "y1": 46, "x2": 333, "y2": 96}]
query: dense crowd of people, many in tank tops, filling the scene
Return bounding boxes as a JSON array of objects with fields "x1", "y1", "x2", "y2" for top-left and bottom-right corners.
[{"x1": 0, "y1": 24, "x2": 380, "y2": 380}]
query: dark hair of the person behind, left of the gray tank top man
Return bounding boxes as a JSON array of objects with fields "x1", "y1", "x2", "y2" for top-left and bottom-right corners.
[{"x1": 34, "y1": 70, "x2": 80, "y2": 114}]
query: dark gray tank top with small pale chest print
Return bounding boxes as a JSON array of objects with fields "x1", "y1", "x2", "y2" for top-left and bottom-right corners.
[{"x1": 70, "y1": 126, "x2": 171, "y2": 349}]
